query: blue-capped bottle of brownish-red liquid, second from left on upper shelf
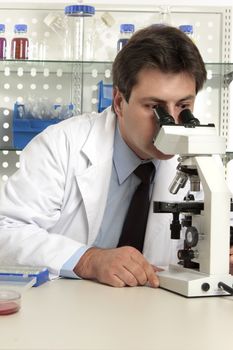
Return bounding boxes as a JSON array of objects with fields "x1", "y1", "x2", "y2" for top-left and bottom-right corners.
[{"x1": 11, "y1": 24, "x2": 29, "y2": 60}]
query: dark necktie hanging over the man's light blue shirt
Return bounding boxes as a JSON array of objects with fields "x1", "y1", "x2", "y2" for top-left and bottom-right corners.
[{"x1": 117, "y1": 162, "x2": 155, "y2": 252}]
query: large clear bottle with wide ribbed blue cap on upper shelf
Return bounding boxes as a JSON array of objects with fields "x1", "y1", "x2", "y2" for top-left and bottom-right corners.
[{"x1": 65, "y1": 5, "x2": 95, "y2": 61}]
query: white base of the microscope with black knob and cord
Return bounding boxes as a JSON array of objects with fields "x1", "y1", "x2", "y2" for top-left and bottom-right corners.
[{"x1": 158, "y1": 265, "x2": 233, "y2": 297}]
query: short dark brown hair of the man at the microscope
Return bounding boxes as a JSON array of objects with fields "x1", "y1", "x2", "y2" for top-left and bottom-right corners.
[{"x1": 112, "y1": 24, "x2": 206, "y2": 102}]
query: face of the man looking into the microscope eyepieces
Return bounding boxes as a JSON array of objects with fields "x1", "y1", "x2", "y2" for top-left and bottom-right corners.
[{"x1": 114, "y1": 69, "x2": 196, "y2": 159}]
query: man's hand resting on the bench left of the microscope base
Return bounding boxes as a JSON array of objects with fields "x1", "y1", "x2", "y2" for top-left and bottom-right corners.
[{"x1": 74, "y1": 246, "x2": 159, "y2": 288}]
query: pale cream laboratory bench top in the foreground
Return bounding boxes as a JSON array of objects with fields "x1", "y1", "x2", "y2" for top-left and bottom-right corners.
[{"x1": 0, "y1": 279, "x2": 233, "y2": 350}]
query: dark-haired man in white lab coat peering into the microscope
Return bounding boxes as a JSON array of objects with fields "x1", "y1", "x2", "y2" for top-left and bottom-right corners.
[{"x1": 0, "y1": 26, "x2": 206, "y2": 287}]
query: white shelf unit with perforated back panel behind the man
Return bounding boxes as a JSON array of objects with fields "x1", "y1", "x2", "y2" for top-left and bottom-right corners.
[{"x1": 0, "y1": 3, "x2": 233, "y2": 186}]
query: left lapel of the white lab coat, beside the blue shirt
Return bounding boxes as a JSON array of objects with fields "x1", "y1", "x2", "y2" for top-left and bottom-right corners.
[{"x1": 76, "y1": 109, "x2": 116, "y2": 244}]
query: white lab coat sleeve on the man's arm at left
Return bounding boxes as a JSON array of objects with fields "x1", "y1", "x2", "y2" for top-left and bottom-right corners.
[{"x1": 0, "y1": 126, "x2": 83, "y2": 275}]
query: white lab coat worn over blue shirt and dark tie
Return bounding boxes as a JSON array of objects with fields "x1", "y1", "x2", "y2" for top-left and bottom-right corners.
[{"x1": 0, "y1": 108, "x2": 186, "y2": 274}]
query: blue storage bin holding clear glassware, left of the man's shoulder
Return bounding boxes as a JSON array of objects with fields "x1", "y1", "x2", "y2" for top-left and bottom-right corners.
[{"x1": 12, "y1": 103, "x2": 62, "y2": 149}]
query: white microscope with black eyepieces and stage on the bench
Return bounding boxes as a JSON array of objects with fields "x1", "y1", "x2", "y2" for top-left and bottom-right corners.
[{"x1": 153, "y1": 106, "x2": 233, "y2": 297}]
